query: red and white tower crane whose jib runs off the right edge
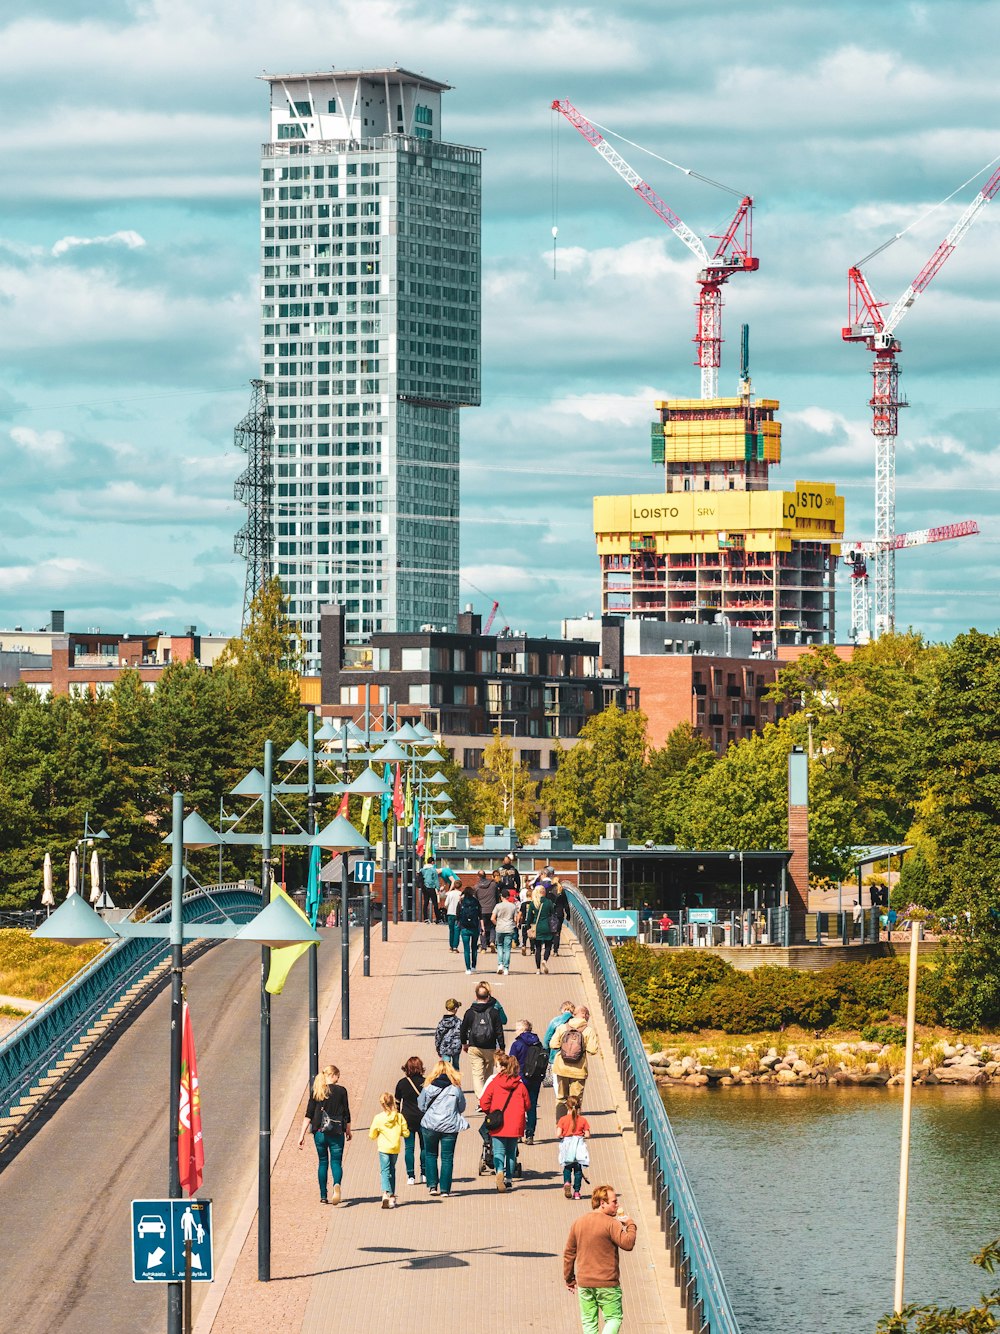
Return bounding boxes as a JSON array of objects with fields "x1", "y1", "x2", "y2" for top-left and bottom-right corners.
[{"x1": 841, "y1": 169, "x2": 1000, "y2": 639}]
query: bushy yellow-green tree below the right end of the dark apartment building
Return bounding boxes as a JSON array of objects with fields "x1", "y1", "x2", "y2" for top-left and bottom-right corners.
[{"x1": 541, "y1": 706, "x2": 647, "y2": 843}]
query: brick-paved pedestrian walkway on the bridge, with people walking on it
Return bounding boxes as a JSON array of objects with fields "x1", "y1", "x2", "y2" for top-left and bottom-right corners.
[{"x1": 204, "y1": 924, "x2": 685, "y2": 1334}]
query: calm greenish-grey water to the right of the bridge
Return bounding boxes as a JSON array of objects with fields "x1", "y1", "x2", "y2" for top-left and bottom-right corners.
[{"x1": 664, "y1": 1086, "x2": 1000, "y2": 1334}]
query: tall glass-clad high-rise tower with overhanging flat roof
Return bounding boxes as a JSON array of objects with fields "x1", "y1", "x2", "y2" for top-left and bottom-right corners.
[{"x1": 260, "y1": 69, "x2": 481, "y2": 672}]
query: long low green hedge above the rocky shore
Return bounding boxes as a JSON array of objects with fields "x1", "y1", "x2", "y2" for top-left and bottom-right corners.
[{"x1": 615, "y1": 944, "x2": 943, "y2": 1033}]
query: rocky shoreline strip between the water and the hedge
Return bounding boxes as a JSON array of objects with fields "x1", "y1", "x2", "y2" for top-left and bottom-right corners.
[{"x1": 647, "y1": 1042, "x2": 1000, "y2": 1089}]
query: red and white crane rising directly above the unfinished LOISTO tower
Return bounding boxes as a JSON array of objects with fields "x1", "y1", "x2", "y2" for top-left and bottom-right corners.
[{"x1": 552, "y1": 100, "x2": 760, "y2": 399}]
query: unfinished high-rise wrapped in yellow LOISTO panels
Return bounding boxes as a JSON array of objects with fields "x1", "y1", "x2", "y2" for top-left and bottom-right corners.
[{"x1": 593, "y1": 383, "x2": 844, "y2": 655}]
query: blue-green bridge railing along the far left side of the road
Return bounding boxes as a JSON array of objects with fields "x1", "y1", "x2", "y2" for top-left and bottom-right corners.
[{"x1": 0, "y1": 882, "x2": 260, "y2": 1118}]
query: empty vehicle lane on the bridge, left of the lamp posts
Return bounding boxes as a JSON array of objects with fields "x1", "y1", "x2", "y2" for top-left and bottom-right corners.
[{"x1": 0, "y1": 931, "x2": 340, "y2": 1334}]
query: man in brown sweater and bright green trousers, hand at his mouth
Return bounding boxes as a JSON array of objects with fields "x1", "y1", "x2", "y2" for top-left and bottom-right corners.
[{"x1": 563, "y1": 1186, "x2": 636, "y2": 1334}]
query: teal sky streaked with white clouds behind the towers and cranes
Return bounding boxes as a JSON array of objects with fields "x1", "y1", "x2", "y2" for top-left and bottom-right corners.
[{"x1": 0, "y1": 0, "x2": 1000, "y2": 640}]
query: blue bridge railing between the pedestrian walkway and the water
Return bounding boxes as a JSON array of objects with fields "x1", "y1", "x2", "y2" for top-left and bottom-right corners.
[{"x1": 567, "y1": 890, "x2": 739, "y2": 1334}]
